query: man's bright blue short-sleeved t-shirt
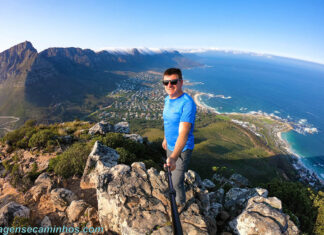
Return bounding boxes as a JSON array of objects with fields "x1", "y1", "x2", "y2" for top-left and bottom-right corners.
[{"x1": 163, "y1": 93, "x2": 196, "y2": 152}]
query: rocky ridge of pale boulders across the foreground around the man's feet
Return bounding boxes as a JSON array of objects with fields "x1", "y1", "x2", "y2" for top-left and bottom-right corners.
[{"x1": 0, "y1": 123, "x2": 299, "y2": 234}]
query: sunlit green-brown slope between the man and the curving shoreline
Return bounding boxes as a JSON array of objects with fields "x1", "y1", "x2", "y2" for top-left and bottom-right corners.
[{"x1": 142, "y1": 116, "x2": 292, "y2": 183}]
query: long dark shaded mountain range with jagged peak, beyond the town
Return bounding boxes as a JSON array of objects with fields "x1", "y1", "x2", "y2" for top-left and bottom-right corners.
[{"x1": 0, "y1": 41, "x2": 200, "y2": 124}]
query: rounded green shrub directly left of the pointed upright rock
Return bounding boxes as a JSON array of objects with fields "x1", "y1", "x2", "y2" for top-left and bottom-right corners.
[{"x1": 49, "y1": 143, "x2": 91, "y2": 178}]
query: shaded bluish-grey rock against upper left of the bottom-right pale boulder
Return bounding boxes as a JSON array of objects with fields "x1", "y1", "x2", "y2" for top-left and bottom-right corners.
[{"x1": 224, "y1": 188, "x2": 268, "y2": 216}]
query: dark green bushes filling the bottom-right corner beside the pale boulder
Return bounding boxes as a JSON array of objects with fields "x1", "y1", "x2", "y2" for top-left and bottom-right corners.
[{"x1": 262, "y1": 179, "x2": 324, "y2": 234}]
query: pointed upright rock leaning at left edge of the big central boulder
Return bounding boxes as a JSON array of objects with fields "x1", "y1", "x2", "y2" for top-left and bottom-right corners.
[{"x1": 80, "y1": 141, "x2": 119, "y2": 187}]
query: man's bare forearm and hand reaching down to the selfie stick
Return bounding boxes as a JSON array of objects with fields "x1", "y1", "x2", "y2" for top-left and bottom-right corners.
[{"x1": 167, "y1": 122, "x2": 191, "y2": 171}]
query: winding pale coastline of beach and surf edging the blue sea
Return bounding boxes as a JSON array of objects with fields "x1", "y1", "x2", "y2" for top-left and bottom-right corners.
[{"x1": 191, "y1": 90, "x2": 324, "y2": 187}]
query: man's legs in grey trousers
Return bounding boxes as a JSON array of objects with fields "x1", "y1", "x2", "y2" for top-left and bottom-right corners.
[{"x1": 167, "y1": 149, "x2": 192, "y2": 204}]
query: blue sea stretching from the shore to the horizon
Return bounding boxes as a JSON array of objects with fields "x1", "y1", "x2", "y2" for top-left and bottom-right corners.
[{"x1": 183, "y1": 52, "x2": 324, "y2": 180}]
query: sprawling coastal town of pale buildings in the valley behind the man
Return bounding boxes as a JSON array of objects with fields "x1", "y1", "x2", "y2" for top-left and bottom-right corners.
[{"x1": 96, "y1": 72, "x2": 212, "y2": 121}]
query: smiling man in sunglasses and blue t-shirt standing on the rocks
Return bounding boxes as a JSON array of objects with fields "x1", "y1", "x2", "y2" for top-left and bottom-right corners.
[{"x1": 162, "y1": 68, "x2": 196, "y2": 206}]
